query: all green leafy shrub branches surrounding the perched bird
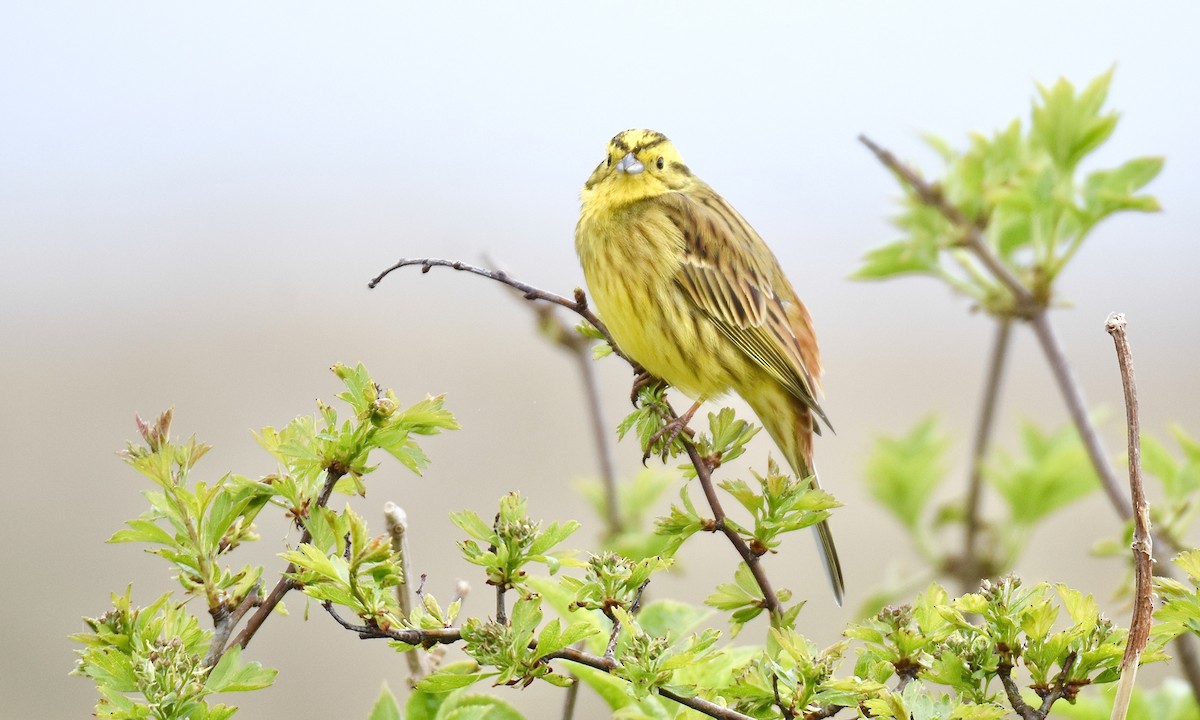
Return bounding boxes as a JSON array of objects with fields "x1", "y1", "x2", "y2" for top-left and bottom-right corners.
[{"x1": 73, "y1": 69, "x2": 1200, "y2": 720}]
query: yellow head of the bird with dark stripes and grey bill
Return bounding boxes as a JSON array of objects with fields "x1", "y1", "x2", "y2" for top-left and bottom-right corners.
[{"x1": 582, "y1": 130, "x2": 694, "y2": 205}]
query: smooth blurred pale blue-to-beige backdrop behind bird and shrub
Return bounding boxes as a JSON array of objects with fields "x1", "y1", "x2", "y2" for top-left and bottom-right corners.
[{"x1": 0, "y1": 1, "x2": 1200, "y2": 718}]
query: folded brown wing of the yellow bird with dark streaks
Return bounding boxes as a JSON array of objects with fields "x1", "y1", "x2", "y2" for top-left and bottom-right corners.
[{"x1": 662, "y1": 185, "x2": 829, "y2": 433}]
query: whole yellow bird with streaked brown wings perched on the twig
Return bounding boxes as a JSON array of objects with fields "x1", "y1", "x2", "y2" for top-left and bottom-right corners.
[{"x1": 575, "y1": 130, "x2": 844, "y2": 605}]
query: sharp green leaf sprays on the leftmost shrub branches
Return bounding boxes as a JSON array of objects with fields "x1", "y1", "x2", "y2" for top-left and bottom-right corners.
[{"x1": 72, "y1": 365, "x2": 457, "y2": 720}]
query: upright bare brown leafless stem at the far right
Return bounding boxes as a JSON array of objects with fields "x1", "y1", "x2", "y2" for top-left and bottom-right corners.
[{"x1": 1104, "y1": 312, "x2": 1154, "y2": 720}]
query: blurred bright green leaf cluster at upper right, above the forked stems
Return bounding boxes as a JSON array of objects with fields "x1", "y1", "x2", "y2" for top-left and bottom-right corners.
[{"x1": 854, "y1": 70, "x2": 1163, "y2": 317}]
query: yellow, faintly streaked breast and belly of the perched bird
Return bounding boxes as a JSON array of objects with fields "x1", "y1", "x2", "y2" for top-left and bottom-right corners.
[{"x1": 575, "y1": 199, "x2": 745, "y2": 397}]
